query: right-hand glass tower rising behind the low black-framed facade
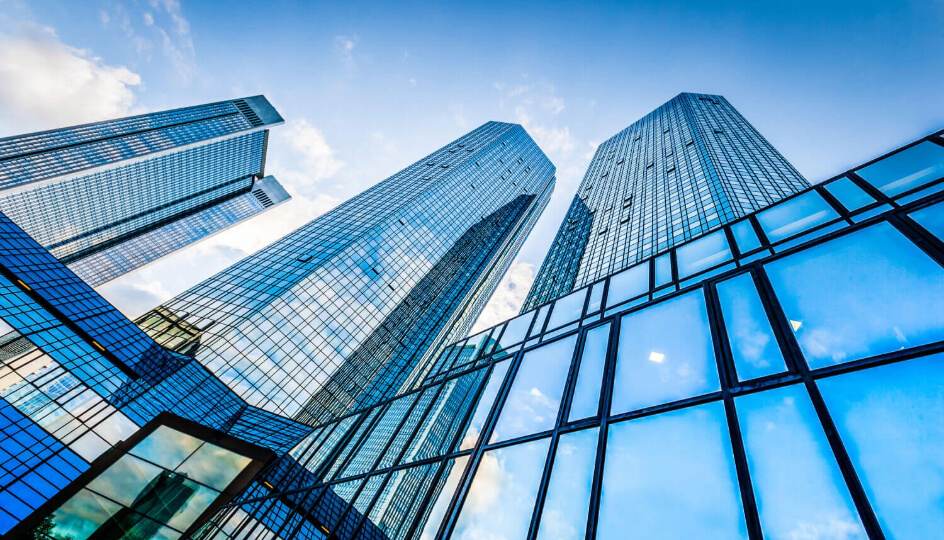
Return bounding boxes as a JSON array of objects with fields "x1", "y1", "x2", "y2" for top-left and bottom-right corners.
[{"x1": 523, "y1": 93, "x2": 809, "y2": 310}]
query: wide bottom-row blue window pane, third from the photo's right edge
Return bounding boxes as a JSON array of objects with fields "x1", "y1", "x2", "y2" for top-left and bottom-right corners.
[{"x1": 597, "y1": 402, "x2": 747, "y2": 540}]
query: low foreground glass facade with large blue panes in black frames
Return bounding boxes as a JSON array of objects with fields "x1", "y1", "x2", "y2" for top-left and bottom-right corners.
[{"x1": 198, "y1": 127, "x2": 944, "y2": 540}]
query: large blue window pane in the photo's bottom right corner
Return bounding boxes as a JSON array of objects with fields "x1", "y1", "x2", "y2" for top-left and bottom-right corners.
[{"x1": 818, "y1": 354, "x2": 944, "y2": 538}]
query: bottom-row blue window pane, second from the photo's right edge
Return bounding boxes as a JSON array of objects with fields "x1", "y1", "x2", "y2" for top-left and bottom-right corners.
[{"x1": 735, "y1": 386, "x2": 865, "y2": 538}]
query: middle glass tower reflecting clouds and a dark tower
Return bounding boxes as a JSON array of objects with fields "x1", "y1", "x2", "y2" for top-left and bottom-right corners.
[{"x1": 139, "y1": 122, "x2": 554, "y2": 422}]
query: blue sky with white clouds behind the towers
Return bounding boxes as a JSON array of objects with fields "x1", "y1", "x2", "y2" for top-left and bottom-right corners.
[{"x1": 0, "y1": 0, "x2": 944, "y2": 327}]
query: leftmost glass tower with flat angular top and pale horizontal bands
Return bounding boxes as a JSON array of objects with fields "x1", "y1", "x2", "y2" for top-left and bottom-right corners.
[{"x1": 0, "y1": 96, "x2": 288, "y2": 286}]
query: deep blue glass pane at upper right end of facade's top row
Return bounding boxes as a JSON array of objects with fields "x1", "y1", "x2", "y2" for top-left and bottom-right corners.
[{"x1": 856, "y1": 141, "x2": 944, "y2": 196}]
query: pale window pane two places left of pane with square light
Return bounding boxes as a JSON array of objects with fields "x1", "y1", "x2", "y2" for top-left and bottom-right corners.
[{"x1": 491, "y1": 335, "x2": 577, "y2": 442}]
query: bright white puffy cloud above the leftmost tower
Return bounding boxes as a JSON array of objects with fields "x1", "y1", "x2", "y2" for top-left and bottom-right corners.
[{"x1": 0, "y1": 27, "x2": 141, "y2": 134}]
